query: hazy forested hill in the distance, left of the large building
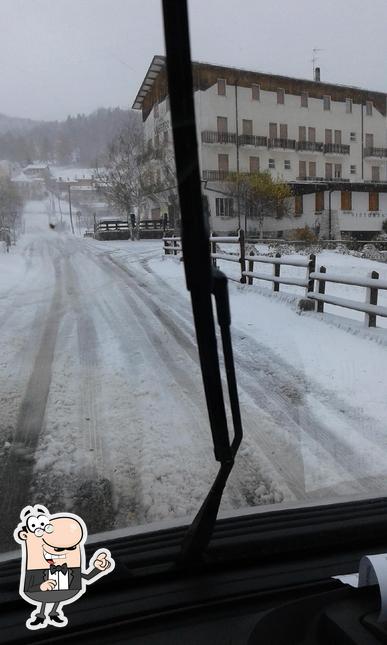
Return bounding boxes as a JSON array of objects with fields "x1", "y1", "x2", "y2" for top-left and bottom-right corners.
[{"x1": 0, "y1": 108, "x2": 141, "y2": 167}]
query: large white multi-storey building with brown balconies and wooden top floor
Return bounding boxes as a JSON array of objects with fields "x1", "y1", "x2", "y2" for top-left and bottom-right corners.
[{"x1": 133, "y1": 56, "x2": 387, "y2": 238}]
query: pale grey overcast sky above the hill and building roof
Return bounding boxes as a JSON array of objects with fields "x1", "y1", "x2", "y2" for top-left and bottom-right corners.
[{"x1": 0, "y1": 0, "x2": 387, "y2": 120}]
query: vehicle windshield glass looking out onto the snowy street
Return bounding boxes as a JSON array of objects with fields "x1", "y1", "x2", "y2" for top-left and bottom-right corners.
[{"x1": 0, "y1": 0, "x2": 387, "y2": 553}]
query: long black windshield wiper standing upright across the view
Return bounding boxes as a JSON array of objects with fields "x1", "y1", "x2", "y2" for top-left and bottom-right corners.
[{"x1": 163, "y1": 0, "x2": 242, "y2": 565}]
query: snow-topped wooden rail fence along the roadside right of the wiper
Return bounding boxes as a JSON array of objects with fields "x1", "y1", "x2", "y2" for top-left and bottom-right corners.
[{"x1": 164, "y1": 230, "x2": 387, "y2": 327}]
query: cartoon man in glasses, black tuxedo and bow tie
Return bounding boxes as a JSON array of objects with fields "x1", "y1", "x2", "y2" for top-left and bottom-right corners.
[{"x1": 14, "y1": 505, "x2": 114, "y2": 629}]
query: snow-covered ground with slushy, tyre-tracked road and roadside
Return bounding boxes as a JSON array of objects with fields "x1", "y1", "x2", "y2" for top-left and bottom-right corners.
[{"x1": 0, "y1": 202, "x2": 387, "y2": 551}]
